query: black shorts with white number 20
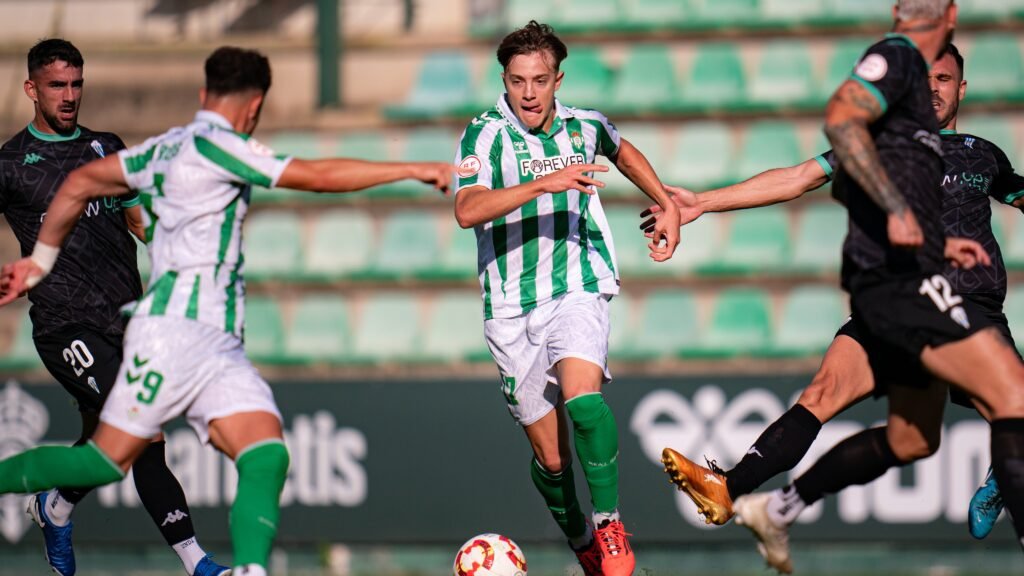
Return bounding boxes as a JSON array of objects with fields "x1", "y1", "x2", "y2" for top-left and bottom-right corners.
[{"x1": 34, "y1": 327, "x2": 122, "y2": 414}]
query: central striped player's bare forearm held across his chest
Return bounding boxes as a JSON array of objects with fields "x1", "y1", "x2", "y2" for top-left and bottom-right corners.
[{"x1": 455, "y1": 164, "x2": 608, "y2": 229}]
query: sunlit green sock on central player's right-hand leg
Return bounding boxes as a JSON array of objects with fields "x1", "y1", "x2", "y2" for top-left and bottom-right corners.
[{"x1": 565, "y1": 393, "x2": 618, "y2": 513}]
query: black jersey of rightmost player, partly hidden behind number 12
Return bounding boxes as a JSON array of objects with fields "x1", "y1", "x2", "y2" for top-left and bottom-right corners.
[{"x1": 815, "y1": 130, "x2": 1024, "y2": 308}]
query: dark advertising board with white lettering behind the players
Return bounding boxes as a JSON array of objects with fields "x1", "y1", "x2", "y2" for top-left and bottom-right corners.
[{"x1": 0, "y1": 376, "x2": 1011, "y2": 547}]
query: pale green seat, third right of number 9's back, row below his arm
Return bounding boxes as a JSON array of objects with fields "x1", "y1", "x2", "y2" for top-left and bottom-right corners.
[{"x1": 371, "y1": 210, "x2": 440, "y2": 279}]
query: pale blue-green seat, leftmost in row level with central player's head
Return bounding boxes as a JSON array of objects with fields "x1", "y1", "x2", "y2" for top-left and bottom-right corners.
[{"x1": 385, "y1": 52, "x2": 473, "y2": 119}]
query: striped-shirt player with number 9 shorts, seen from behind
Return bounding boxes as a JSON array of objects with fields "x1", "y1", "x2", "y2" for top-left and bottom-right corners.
[{"x1": 0, "y1": 47, "x2": 453, "y2": 576}]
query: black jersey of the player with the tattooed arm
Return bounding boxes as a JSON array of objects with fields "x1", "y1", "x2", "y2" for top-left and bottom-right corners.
[{"x1": 835, "y1": 34, "x2": 944, "y2": 289}]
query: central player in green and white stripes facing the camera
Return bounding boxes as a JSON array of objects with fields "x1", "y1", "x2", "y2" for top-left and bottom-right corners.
[{"x1": 455, "y1": 22, "x2": 679, "y2": 576}]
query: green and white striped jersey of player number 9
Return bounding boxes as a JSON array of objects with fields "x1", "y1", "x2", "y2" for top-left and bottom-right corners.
[{"x1": 118, "y1": 111, "x2": 291, "y2": 337}]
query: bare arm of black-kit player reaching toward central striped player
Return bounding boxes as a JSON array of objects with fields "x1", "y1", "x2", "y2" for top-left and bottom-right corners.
[{"x1": 640, "y1": 158, "x2": 828, "y2": 234}]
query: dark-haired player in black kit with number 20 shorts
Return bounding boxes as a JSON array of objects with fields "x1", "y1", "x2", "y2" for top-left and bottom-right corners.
[{"x1": 0, "y1": 39, "x2": 229, "y2": 576}]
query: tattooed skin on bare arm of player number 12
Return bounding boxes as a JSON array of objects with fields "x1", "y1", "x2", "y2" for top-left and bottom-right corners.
[{"x1": 825, "y1": 82, "x2": 907, "y2": 214}]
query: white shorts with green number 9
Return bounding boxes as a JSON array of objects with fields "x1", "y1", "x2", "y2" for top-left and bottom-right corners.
[{"x1": 99, "y1": 317, "x2": 281, "y2": 443}]
